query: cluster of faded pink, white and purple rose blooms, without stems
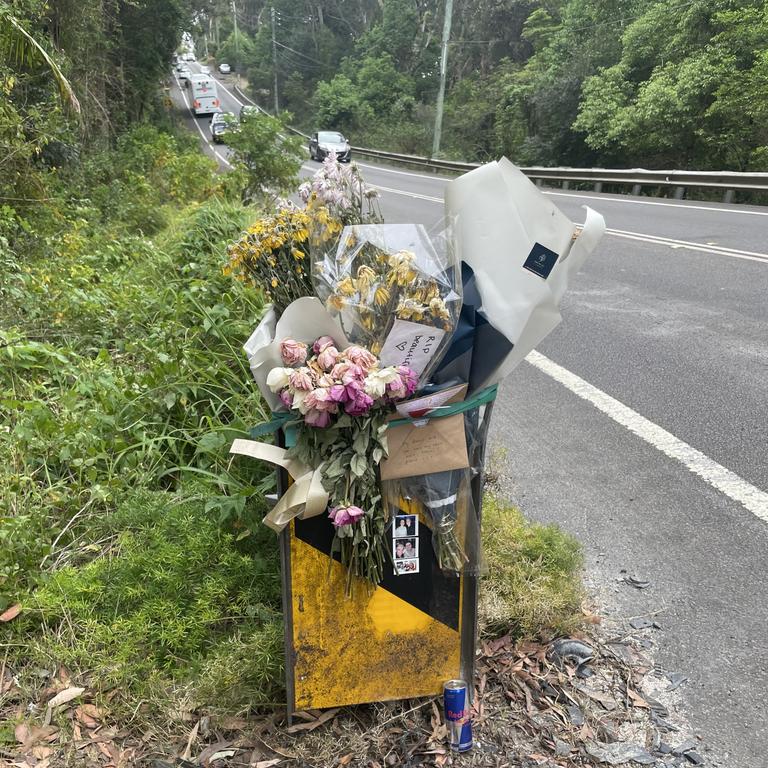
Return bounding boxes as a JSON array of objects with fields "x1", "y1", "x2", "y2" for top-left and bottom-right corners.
[{"x1": 267, "y1": 336, "x2": 418, "y2": 428}]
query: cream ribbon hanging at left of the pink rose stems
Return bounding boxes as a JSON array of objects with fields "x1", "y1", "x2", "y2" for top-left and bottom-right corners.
[{"x1": 229, "y1": 439, "x2": 329, "y2": 533}]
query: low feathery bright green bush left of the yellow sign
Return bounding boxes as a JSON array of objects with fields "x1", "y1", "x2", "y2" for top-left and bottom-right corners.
[{"x1": 15, "y1": 491, "x2": 282, "y2": 710}]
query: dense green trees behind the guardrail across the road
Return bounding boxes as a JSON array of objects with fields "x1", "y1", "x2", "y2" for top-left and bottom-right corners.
[{"x1": 197, "y1": 0, "x2": 768, "y2": 169}]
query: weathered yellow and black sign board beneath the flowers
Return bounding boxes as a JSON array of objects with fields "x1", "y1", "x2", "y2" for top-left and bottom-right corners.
[{"x1": 283, "y1": 503, "x2": 468, "y2": 710}]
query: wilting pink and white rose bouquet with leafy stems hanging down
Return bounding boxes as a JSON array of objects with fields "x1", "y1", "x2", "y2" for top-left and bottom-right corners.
[{"x1": 266, "y1": 336, "x2": 417, "y2": 593}]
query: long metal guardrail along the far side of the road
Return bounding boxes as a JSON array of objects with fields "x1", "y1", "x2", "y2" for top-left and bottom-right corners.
[{"x1": 352, "y1": 147, "x2": 768, "y2": 203}]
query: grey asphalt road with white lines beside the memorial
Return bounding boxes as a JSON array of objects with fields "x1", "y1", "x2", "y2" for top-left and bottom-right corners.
[{"x1": 172, "y1": 69, "x2": 768, "y2": 768}]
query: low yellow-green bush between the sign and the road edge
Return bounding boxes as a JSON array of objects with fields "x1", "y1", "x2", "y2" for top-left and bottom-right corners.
[{"x1": 480, "y1": 495, "x2": 584, "y2": 637}]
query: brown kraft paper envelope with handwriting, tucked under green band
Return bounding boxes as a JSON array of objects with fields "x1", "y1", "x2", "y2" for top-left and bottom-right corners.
[{"x1": 379, "y1": 413, "x2": 469, "y2": 480}]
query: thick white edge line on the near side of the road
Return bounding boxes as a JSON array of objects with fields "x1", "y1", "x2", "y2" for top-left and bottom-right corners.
[{"x1": 526, "y1": 350, "x2": 768, "y2": 523}]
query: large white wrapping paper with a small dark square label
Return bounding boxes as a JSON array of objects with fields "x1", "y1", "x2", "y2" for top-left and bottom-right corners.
[{"x1": 445, "y1": 158, "x2": 605, "y2": 386}]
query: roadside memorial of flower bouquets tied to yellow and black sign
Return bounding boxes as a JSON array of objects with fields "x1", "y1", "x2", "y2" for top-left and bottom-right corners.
[{"x1": 224, "y1": 158, "x2": 605, "y2": 713}]
